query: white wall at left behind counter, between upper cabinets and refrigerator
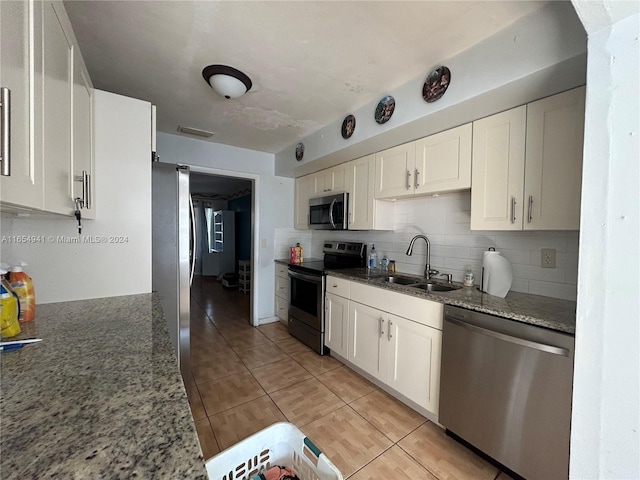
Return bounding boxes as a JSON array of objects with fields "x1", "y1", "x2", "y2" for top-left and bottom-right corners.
[{"x1": 1, "y1": 90, "x2": 151, "y2": 303}]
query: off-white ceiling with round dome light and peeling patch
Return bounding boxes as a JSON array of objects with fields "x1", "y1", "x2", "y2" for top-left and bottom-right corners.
[{"x1": 64, "y1": 0, "x2": 547, "y2": 153}]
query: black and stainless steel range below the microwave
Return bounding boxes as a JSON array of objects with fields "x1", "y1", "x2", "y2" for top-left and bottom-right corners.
[{"x1": 288, "y1": 241, "x2": 367, "y2": 355}]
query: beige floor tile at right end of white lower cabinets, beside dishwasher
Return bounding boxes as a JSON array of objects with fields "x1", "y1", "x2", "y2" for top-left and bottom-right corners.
[{"x1": 350, "y1": 390, "x2": 427, "y2": 443}]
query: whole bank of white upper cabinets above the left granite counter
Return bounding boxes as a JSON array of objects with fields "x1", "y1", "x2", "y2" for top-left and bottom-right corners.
[{"x1": 0, "y1": 1, "x2": 93, "y2": 218}]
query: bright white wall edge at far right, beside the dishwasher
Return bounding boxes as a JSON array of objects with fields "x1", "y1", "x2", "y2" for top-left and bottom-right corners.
[{"x1": 570, "y1": 5, "x2": 640, "y2": 479}]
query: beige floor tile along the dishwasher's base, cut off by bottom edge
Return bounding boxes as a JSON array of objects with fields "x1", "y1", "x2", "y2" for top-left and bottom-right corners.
[{"x1": 398, "y1": 422, "x2": 498, "y2": 480}]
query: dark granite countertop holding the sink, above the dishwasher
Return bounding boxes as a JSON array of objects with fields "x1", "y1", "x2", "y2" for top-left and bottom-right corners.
[{"x1": 328, "y1": 268, "x2": 576, "y2": 335}]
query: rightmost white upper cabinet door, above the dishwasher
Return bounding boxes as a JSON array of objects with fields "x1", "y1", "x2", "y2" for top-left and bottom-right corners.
[{"x1": 524, "y1": 87, "x2": 585, "y2": 230}]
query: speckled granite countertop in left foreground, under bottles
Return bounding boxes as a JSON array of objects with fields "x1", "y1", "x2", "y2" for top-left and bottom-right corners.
[{"x1": 0, "y1": 294, "x2": 207, "y2": 480}]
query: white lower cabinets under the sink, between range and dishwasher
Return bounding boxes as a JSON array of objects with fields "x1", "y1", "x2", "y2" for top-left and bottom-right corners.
[{"x1": 332, "y1": 277, "x2": 444, "y2": 416}]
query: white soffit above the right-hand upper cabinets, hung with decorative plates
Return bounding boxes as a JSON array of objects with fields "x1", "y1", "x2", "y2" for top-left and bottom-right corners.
[{"x1": 276, "y1": 2, "x2": 586, "y2": 176}]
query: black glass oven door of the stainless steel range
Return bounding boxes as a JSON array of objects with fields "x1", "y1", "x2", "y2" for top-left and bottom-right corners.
[{"x1": 289, "y1": 269, "x2": 324, "y2": 332}]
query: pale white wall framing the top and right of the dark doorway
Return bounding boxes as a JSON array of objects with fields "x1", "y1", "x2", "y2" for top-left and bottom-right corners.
[{"x1": 158, "y1": 133, "x2": 294, "y2": 322}]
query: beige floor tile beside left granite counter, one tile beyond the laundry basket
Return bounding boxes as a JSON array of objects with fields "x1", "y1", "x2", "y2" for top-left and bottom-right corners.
[{"x1": 198, "y1": 372, "x2": 265, "y2": 416}]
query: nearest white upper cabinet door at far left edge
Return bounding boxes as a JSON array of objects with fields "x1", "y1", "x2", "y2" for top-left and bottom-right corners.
[{"x1": 0, "y1": 2, "x2": 43, "y2": 209}]
